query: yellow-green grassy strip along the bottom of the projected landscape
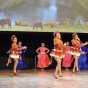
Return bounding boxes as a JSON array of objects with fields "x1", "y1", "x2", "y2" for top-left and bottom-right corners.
[{"x1": 0, "y1": 25, "x2": 88, "y2": 33}]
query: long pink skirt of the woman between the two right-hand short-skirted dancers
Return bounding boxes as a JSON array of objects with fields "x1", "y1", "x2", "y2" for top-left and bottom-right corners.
[{"x1": 62, "y1": 53, "x2": 72, "y2": 67}]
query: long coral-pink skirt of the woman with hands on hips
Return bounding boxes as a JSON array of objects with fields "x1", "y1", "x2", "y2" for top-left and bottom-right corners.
[{"x1": 37, "y1": 54, "x2": 51, "y2": 68}]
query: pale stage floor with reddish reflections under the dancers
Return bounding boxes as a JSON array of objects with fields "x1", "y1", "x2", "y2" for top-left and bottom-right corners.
[{"x1": 0, "y1": 70, "x2": 88, "y2": 88}]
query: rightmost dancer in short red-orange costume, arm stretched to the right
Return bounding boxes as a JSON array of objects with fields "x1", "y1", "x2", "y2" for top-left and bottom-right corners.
[{"x1": 71, "y1": 33, "x2": 88, "y2": 72}]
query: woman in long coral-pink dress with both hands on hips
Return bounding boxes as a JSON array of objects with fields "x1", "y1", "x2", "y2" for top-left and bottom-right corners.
[{"x1": 36, "y1": 43, "x2": 50, "y2": 70}]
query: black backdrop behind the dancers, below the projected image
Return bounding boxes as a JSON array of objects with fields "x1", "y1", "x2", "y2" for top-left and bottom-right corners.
[{"x1": 0, "y1": 31, "x2": 88, "y2": 70}]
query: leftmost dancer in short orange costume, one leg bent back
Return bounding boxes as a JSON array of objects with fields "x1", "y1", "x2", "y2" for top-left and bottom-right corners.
[{"x1": 7, "y1": 36, "x2": 20, "y2": 75}]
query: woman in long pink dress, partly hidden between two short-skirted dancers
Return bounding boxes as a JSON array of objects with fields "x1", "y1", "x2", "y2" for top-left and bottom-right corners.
[{"x1": 62, "y1": 42, "x2": 72, "y2": 70}]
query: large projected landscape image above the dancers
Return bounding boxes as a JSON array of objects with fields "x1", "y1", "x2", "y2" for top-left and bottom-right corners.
[{"x1": 0, "y1": 0, "x2": 88, "y2": 33}]
